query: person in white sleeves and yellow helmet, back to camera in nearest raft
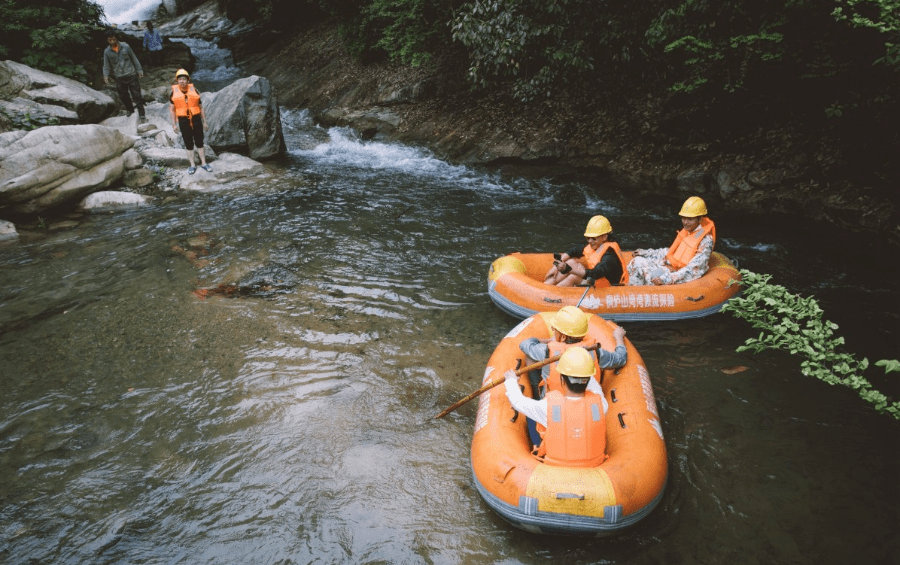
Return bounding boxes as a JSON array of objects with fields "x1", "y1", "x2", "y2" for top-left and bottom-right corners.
[{"x1": 503, "y1": 347, "x2": 607, "y2": 467}]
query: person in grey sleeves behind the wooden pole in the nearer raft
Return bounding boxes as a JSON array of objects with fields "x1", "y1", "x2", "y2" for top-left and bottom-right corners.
[{"x1": 519, "y1": 306, "x2": 628, "y2": 399}]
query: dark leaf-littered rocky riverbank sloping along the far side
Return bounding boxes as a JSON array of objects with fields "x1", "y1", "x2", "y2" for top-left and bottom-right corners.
[{"x1": 224, "y1": 16, "x2": 900, "y2": 244}]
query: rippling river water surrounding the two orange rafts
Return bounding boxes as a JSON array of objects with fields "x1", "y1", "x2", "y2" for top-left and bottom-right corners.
[{"x1": 0, "y1": 53, "x2": 900, "y2": 564}]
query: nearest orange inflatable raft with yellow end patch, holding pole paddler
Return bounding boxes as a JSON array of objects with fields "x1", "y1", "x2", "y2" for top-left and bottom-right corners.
[{"x1": 472, "y1": 313, "x2": 668, "y2": 536}]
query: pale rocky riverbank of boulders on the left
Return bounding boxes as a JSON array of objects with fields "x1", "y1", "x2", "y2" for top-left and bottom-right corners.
[{"x1": 0, "y1": 53, "x2": 284, "y2": 239}]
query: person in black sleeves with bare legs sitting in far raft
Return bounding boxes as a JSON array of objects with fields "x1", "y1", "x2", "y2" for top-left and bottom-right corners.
[{"x1": 544, "y1": 216, "x2": 628, "y2": 287}]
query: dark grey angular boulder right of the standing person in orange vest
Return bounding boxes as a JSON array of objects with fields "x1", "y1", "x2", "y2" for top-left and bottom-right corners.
[{"x1": 202, "y1": 75, "x2": 285, "y2": 159}]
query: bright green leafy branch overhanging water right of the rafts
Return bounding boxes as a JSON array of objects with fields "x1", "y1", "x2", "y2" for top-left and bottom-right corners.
[{"x1": 722, "y1": 269, "x2": 900, "y2": 420}]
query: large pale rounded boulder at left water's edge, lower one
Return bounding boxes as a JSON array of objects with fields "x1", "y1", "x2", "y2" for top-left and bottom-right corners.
[{"x1": 0, "y1": 124, "x2": 134, "y2": 214}]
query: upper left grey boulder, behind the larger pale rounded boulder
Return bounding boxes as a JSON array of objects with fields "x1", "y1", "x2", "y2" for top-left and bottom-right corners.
[{"x1": 0, "y1": 61, "x2": 115, "y2": 123}]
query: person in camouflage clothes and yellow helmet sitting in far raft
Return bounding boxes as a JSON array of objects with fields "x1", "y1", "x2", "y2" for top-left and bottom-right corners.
[{"x1": 628, "y1": 196, "x2": 716, "y2": 285}]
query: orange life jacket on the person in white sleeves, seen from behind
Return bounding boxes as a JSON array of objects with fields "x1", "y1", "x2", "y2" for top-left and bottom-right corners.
[{"x1": 537, "y1": 391, "x2": 606, "y2": 467}]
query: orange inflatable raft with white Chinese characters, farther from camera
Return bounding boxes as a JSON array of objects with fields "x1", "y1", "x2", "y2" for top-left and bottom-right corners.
[{"x1": 488, "y1": 251, "x2": 741, "y2": 322}]
